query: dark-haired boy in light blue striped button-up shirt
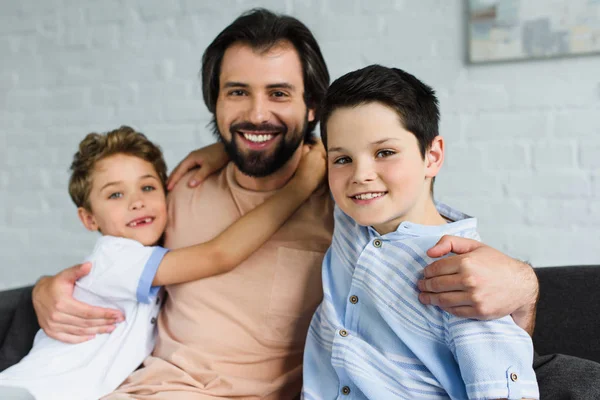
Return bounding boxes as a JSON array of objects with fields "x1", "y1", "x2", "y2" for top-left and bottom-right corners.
[{"x1": 303, "y1": 65, "x2": 539, "y2": 400}]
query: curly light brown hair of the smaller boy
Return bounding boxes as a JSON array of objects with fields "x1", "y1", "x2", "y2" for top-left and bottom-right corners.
[{"x1": 69, "y1": 125, "x2": 167, "y2": 211}]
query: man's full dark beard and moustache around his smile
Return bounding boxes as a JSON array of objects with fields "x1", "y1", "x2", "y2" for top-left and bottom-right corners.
[{"x1": 212, "y1": 116, "x2": 308, "y2": 178}]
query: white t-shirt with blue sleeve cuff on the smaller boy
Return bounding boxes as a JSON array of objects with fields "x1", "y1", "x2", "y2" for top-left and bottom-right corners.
[{"x1": 0, "y1": 236, "x2": 167, "y2": 400}]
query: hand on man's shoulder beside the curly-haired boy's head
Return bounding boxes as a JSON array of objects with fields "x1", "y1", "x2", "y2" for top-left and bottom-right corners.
[{"x1": 167, "y1": 142, "x2": 229, "y2": 190}]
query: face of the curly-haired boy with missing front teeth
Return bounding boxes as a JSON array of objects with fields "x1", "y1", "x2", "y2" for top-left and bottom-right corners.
[{"x1": 78, "y1": 154, "x2": 167, "y2": 246}]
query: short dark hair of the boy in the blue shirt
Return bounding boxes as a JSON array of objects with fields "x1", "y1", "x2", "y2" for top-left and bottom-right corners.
[{"x1": 321, "y1": 65, "x2": 440, "y2": 157}]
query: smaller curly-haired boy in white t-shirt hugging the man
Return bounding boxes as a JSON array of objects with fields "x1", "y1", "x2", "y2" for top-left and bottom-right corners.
[{"x1": 0, "y1": 126, "x2": 325, "y2": 400}]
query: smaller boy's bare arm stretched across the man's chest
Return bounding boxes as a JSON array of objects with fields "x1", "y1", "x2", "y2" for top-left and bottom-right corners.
[{"x1": 152, "y1": 144, "x2": 325, "y2": 286}]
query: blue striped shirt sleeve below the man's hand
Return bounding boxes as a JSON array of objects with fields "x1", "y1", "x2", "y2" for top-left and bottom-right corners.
[{"x1": 444, "y1": 313, "x2": 539, "y2": 399}]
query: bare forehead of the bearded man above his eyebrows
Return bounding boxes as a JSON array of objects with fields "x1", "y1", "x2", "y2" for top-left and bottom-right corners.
[{"x1": 219, "y1": 41, "x2": 303, "y2": 87}]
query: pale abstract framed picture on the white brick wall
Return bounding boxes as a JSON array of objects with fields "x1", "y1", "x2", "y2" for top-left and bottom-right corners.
[{"x1": 468, "y1": 0, "x2": 600, "y2": 63}]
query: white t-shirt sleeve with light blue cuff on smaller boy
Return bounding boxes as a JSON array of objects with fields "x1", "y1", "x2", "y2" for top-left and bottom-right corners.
[{"x1": 77, "y1": 237, "x2": 168, "y2": 303}]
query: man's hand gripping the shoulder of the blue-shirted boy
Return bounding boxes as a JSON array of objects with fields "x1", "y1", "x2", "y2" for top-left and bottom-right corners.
[{"x1": 418, "y1": 236, "x2": 538, "y2": 335}]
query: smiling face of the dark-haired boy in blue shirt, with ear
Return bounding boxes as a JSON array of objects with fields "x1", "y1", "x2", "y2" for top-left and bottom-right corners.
[{"x1": 327, "y1": 103, "x2": 443, "y2": 234}]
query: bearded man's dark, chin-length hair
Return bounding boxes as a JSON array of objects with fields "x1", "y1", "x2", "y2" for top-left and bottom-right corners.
[{"x1": 202, "y1": 8, "x2": 329, "y2": 139}]
